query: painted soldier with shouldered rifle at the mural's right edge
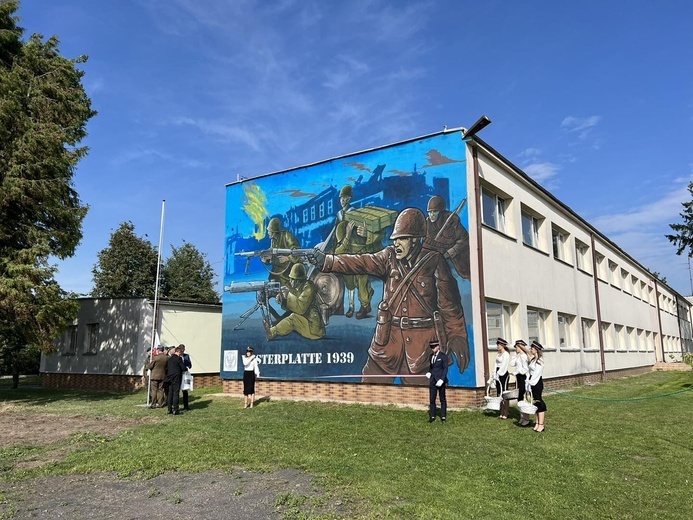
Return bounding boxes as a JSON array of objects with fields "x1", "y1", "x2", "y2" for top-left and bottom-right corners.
[{"x1": 424, "y1": 195, "x2": 469, "y2": 280}]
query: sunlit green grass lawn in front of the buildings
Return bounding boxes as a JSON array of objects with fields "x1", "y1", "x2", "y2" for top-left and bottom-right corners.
[{"x1": 0, "y1": 372, "x2": 693, "y2": 519}]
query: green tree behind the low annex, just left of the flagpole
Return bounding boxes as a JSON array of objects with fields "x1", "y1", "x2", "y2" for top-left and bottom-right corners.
[{"x1": 91, "y1": 222, "x2": 158, "y2": 298}]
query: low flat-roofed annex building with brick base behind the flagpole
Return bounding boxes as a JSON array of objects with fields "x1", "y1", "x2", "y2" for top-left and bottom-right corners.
[{"x1": 40, "y1": 298, "x2": 221, "y2": 390}]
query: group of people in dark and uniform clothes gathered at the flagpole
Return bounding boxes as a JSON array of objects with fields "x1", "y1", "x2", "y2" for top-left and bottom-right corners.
[{"x1": 147, "y1": 344, "x2": 192, "y2": 415}]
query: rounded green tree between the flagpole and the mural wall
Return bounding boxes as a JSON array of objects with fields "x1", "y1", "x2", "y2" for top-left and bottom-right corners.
[{"x1": 163, "y1": 243, "x2": 219, "y2": 302}]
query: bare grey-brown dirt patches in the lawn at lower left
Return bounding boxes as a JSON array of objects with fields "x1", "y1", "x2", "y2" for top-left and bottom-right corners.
[{"x1": 0, "y1": 405, "x2": 352, "y2": 520}]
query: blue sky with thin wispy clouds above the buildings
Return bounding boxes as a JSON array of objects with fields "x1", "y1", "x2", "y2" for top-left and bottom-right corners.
[{"x1": 19, "y1": 0, "x2": 693, "y2": 294}]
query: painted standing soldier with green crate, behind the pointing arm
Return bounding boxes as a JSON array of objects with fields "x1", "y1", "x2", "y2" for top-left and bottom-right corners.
[{"x1": 335, "y1": 184, "x2": 385, "y2": 320}]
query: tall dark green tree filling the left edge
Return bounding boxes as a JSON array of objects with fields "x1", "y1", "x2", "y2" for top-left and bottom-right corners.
[{"x1": 0, "y1": 0, "x2": 96, "y2": 387}]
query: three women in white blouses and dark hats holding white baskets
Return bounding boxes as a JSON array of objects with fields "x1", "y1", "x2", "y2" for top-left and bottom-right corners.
[{"x1": 494, "y1": 338, "x2": 546, "y2": 433}]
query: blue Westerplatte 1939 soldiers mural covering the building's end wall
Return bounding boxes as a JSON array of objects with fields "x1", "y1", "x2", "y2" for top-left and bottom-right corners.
[{"x1": 221, "y1": 132, "x2": 476, "y2": 386}]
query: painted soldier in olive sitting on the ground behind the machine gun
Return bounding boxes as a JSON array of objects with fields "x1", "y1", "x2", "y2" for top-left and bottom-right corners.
[{"x1": 263, "y1": 264, "x2": 325, "y2": 340}]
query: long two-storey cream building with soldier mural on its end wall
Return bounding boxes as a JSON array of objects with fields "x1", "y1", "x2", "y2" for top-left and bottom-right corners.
[{"x1": 221, "y1": 130, "x2": 692, "y2": 396}]
